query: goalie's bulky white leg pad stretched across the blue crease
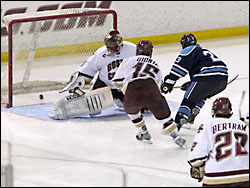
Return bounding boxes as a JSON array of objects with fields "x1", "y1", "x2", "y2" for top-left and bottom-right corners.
[{"x1": 49, "y1": 87, "x2": 114, "y2": 120}]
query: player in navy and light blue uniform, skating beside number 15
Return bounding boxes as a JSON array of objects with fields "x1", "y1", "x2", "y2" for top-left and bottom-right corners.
[{"x1": 161, "y1": 34, "x2": 228, "y2": 130}]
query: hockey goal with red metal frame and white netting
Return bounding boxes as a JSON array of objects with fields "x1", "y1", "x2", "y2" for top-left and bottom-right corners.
[{"x1": 1, "y1": 8, "x2": 117, "y2": 107}]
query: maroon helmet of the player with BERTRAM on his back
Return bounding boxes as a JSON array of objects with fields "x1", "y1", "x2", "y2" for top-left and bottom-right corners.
[{"x1": 212, "y1": 97, "x2": 233, "y2": 118}]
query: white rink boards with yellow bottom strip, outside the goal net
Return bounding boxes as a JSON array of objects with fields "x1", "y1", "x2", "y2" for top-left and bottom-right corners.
[{"x1": 1, "y1": 1, "x2": 249, "y2": 62}]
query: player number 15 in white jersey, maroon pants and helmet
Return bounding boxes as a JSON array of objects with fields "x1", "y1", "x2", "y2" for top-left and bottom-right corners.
[{"x1": 113, "y1": 40, "x2": 185, "y2": 147}]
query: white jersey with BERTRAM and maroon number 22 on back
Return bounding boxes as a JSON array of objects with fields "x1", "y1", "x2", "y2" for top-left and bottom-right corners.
[{"x1": 188, "y1": 118, "x2": 249, "y2": 184}]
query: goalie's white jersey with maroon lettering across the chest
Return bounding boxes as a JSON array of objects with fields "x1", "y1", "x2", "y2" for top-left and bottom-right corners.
[{"x1": 77, "y1": 41, "x2": 136, "y2": 89}]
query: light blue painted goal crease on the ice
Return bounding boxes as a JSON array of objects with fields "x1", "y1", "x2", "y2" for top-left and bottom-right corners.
[{"x1": 3, "y1": 102, "x2": 179, "y2": 122}]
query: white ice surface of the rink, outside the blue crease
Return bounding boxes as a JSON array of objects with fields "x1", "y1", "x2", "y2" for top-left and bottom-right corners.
[{"x1": 1, "y1": 36, "x2": 249, "y2": 187}]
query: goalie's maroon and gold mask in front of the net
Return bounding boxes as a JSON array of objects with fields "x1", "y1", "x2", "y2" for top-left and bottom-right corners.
[{"x1": 104, "y1": 30, "x2": 122, "y2": 55}]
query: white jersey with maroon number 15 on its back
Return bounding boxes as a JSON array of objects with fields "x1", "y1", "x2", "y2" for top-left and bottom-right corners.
[{"x1": 113, "y1": 55, "x2": 162, "y2": 93}]
